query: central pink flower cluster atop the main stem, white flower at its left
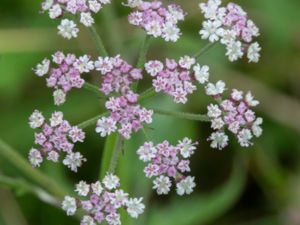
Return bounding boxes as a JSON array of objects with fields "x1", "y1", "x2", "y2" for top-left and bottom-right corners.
[{"x1": 96, "y1": 91, "x2": 153, "y2": 139}]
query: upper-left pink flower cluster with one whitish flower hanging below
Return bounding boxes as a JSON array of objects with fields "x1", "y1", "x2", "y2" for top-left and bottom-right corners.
[{"x1": 33, "y1": 52, "x2": 94, "y2": 105}]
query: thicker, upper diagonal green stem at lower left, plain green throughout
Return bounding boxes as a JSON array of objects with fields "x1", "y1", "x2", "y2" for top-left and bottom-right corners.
[{"x1": 0, "y1": 139, "x2": 66, "y2": 198}]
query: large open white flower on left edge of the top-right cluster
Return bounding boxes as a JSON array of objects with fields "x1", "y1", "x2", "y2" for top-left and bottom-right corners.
[{"x1": 199, "y1": 20, "x2": 223, "y2": 42}]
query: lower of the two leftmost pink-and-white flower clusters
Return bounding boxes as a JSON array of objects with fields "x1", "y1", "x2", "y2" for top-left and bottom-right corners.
[{"x1": 29, "y1": 110, "x2": 86, "y2": 172}]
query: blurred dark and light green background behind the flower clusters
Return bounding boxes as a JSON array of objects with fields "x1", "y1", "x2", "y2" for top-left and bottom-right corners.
[{"x1": 0, "y1": 0, "x2": 300, "y2": 225}]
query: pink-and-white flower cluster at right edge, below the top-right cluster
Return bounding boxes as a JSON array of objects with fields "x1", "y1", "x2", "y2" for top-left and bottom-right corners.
[{"x1": 206, "y1": 81, "x2": 263, "y2": 150}]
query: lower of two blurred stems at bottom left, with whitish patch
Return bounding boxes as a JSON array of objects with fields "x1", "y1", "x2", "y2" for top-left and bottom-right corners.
[{"x1": 0, "y1": 175, "x2": 59, "y2": 207}]
